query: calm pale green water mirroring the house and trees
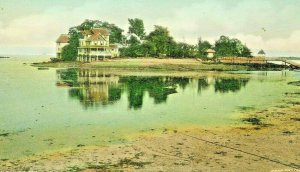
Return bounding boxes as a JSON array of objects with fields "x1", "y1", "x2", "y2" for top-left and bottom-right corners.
[{"x1": 0, "y1": 58, "x2": 300, "y2": 159}]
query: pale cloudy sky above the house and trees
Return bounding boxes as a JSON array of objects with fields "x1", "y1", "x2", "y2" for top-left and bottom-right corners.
[{"x1": 0, "y1": 0, "x2": 300, "y2": 57}]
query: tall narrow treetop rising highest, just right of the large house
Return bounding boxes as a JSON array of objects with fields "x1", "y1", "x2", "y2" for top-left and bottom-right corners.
[{"x1": 128, "y1": 18, "x2": 146, "y2": 39}]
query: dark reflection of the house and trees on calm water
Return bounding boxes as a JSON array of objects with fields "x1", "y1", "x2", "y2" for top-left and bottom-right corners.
[{"x1": 57, "y1": 69, "x2": 249, "y2": 109}]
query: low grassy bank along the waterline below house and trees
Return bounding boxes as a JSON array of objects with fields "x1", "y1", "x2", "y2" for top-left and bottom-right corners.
[{"x1": 32, "y1": 58, "x2": 283, "y2": 71}]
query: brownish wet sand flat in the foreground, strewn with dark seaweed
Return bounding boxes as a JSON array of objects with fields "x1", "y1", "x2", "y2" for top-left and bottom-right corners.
[{"x1": 0, "y1": 90, "x2": 300, "y2": 171}]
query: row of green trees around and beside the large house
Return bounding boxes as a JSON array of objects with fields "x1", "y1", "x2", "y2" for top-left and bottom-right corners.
[{"x1": 62, "y1": 18, "x2": 252, "y2": 60}]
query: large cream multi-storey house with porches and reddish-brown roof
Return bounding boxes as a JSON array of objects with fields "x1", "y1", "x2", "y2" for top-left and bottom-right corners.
[{"x1": 77, "y1": 28, "x2": 119, "y2": 62}]
